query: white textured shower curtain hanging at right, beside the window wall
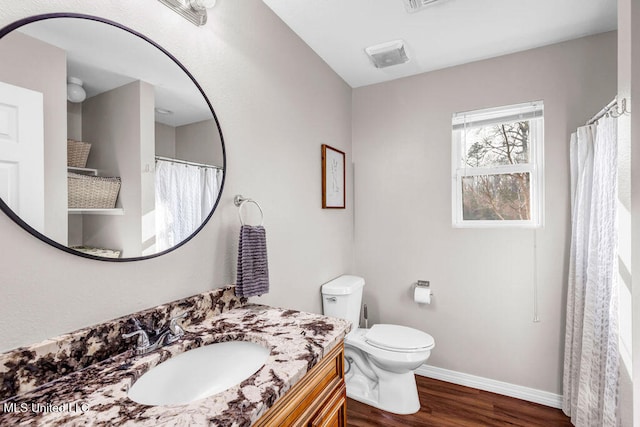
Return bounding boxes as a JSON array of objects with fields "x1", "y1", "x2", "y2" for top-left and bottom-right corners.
[{"x1": 563, "y1": 117, "x2": 619, "y2": 427}]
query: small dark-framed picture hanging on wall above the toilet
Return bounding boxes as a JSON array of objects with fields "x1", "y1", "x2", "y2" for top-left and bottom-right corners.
[{"x1": 322, "y1": 144, "x2": 346, "y2": 209}]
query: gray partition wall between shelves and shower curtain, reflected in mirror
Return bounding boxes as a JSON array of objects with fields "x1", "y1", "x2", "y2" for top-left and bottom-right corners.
[{"x1": 82, "y1": 81, "x2": 155, "y2": 257}]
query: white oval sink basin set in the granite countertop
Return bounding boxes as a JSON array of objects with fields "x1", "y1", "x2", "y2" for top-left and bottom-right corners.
[{"x1": 129, "y1": 341, "x2": 269, "y2": 405}]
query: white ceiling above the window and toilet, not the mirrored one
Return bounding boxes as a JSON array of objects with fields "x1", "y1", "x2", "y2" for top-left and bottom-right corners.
[{"x1": 263, "y1": 0, "x2": 617, "y2": 88}]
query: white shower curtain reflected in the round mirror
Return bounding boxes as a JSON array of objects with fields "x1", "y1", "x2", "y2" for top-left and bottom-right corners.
[{"x1": 155, "y1": 160, "x2": 222, "y2": 252}]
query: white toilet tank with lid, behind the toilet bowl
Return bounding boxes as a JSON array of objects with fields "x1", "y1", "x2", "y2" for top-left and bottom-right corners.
[{"x1": 322, "y1": 276, "x2": 364, "y2": 330}]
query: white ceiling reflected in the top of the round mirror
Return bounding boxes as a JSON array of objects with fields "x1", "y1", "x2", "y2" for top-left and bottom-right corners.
[{"x1": 18, "y1": 18, "x2": 212, "y2": 127}]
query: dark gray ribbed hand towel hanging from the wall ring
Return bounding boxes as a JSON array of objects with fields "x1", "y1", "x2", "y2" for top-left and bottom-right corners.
[{"x1": 236, "y1": 225, "x2": 269, "y2": 297}]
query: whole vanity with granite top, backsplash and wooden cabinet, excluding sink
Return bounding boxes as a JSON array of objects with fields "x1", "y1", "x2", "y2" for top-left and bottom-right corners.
[{"x1": 0, "y1": 287, "x2": 350, "y2": 426}]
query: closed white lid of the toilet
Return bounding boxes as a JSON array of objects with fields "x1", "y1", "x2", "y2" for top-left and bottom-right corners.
[{"x1": 364, "y1": 324, "x2": 435, "y2": 351}]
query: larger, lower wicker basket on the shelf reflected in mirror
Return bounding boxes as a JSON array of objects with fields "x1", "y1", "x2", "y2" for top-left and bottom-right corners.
[{"x1": 67, "y1": 172, "x2": 120, "y2": 209}]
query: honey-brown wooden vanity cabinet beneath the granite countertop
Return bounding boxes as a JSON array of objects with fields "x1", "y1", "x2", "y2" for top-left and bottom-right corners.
[{"x1": 254, "y1": 343, "x2": 347, "y2": 427}]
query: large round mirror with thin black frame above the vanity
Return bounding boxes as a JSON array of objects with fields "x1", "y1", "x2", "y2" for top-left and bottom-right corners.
[{"x1": 0, "y1": 14, "x2": 226, "y2": 261}]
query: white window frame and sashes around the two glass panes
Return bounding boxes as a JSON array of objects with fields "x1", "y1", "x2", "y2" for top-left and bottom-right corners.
[{"x1": 451, "y1": 101, "x2": 544, "y2": 228}]
